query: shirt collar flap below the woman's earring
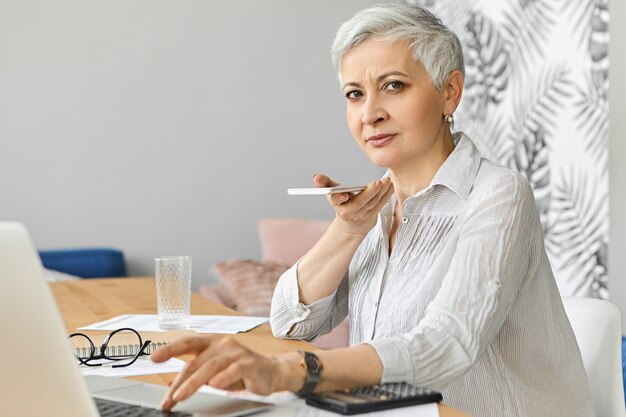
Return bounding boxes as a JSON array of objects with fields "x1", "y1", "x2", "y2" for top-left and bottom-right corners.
[{"x1": 427, "y1": 132, "x2": 481, "y2": 200}]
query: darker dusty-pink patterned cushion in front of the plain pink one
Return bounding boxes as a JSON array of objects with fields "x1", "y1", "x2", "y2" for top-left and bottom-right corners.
[{"x1": 213, "y1": 260, "x2": 289, "y2": 317}]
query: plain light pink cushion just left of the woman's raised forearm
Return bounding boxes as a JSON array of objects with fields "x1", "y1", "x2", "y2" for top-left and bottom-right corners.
[{"x1": 259, "y1": 218, "x2": 330, "y2": 265}]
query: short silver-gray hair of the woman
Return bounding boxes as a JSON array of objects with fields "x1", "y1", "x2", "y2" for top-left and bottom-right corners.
[{"x1": 331, "y1": 2, "x2": 465, "y2": 89}]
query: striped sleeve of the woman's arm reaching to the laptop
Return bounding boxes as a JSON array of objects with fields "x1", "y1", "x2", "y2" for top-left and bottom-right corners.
[{"x1": 368, "y1": 175, "x2": 537, "y2": 389}]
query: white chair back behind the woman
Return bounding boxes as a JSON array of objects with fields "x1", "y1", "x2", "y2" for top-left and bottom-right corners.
[{"x1": 563, "y1": 297, "x2": 626, "y2": 417}]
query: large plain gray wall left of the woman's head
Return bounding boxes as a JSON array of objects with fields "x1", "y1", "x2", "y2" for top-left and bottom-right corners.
[{"x1": 0, "y1": 0, "x2": 382, "y2": 284}]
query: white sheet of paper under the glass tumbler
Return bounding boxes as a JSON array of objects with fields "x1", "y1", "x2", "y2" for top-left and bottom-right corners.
[{"x1": 80, "y1": 314, "x2": 268, "y2": 334}]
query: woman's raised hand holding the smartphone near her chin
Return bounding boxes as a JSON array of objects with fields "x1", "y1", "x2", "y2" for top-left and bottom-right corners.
[{"x1": 313, "y1": 174, "x2": 393, "y2": 235}]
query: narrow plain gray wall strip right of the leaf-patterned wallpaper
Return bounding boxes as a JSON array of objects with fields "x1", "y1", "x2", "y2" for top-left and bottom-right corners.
[{"x1": 609, "y1": 0, "x2": 626, "y2": 334}]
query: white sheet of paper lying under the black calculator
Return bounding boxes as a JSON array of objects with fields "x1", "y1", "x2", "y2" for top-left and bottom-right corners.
[{"x1": 200, "y1": 385, "x2": 439, "y2": 417}]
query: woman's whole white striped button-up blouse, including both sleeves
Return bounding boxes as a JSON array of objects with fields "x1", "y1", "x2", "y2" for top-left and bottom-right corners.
[{"x1": 271, "y1": 133, "x2": 594, "y2": 417}]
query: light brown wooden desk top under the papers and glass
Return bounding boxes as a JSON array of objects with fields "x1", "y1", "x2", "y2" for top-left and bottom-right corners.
[{"x1": 50, "y1": 278, "x2": 465, "y2": 417}]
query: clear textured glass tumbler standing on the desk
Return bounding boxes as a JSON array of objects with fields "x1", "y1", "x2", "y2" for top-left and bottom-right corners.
[{"x1": 154, "y1": 256, "x2": 191, "y2": 330}]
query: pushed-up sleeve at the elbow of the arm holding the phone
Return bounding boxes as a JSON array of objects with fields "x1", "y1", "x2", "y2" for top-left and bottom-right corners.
[{"x1": 270, "y1": 261, "x2": 348, "y2": 340}]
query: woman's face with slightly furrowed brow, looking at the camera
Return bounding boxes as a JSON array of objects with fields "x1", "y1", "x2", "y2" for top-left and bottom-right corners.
[{"x1": 341, "y1": 38, "x2": 450, "y2": 170}]
